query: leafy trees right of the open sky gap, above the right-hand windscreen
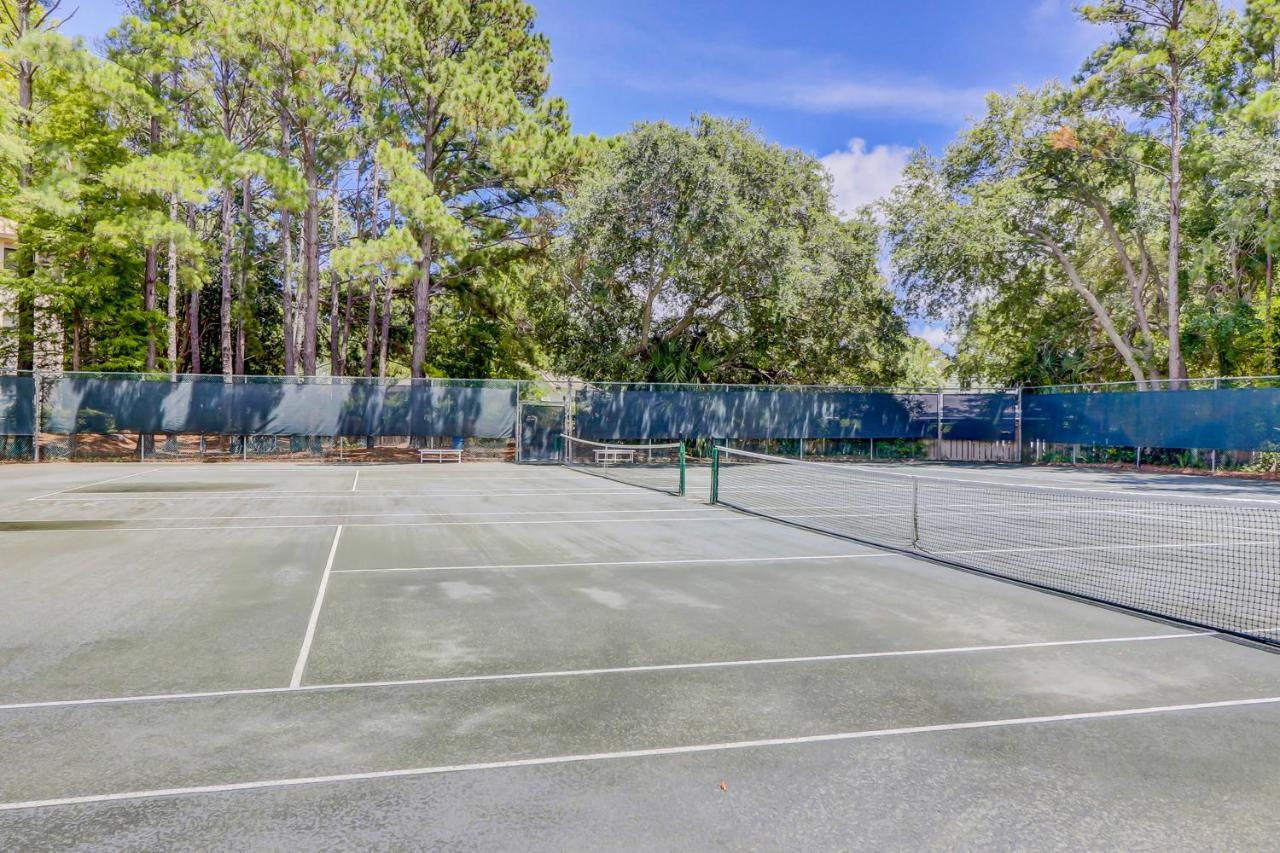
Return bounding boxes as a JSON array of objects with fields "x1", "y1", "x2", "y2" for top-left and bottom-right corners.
[{"x1": 883, "y1": 0, "x2": 1280, "y2": 387}]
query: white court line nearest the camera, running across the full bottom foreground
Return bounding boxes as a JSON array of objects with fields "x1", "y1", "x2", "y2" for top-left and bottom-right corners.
[{"x1": 0, "y1": 697, "x2": 1280, "y2": 812}]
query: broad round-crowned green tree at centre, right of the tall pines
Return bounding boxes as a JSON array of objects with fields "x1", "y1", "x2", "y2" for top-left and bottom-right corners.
[{"x1": 553, "y1": 117, "x2": 905, "y2": 383}]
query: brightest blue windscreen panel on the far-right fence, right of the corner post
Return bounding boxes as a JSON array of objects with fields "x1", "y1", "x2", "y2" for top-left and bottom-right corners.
[{"x1": 1023, "y1": 388, "x2": 1280, "y2": 450}]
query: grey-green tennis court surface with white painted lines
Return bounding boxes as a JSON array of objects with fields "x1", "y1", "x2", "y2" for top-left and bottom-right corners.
[{"x1": 0, "y1": 452, "x2": 1280, "y2": 850}]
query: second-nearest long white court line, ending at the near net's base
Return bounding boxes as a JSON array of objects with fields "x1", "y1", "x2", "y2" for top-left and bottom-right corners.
[{"x1": 0, "y1": 631, "x2": 1217, "y2": 711}]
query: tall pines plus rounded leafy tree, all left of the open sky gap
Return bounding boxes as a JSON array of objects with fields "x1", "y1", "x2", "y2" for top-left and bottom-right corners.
[{"x1": 0, "y1": 0, "x2": 906, "y2": 380}]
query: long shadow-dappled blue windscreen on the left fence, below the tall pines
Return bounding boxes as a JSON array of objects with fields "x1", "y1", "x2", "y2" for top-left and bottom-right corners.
[{"x1": 42, "y1": 377, "x2": 517, "y2": 438}]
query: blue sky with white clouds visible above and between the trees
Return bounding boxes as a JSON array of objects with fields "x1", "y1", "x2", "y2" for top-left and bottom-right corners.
[{"x1": 64, "y1": 0, "x2": 1106, "y2": 342}]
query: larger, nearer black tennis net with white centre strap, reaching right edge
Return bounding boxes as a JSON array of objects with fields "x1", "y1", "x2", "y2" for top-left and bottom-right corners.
[{"x1": 712, "y1": 447, "x2": 1280, "y2": 644}]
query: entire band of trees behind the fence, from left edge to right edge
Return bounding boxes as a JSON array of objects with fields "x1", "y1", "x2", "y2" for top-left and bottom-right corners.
[{"x1": 0, "y1": 0, "x2": 1280, "y2": 387}]
